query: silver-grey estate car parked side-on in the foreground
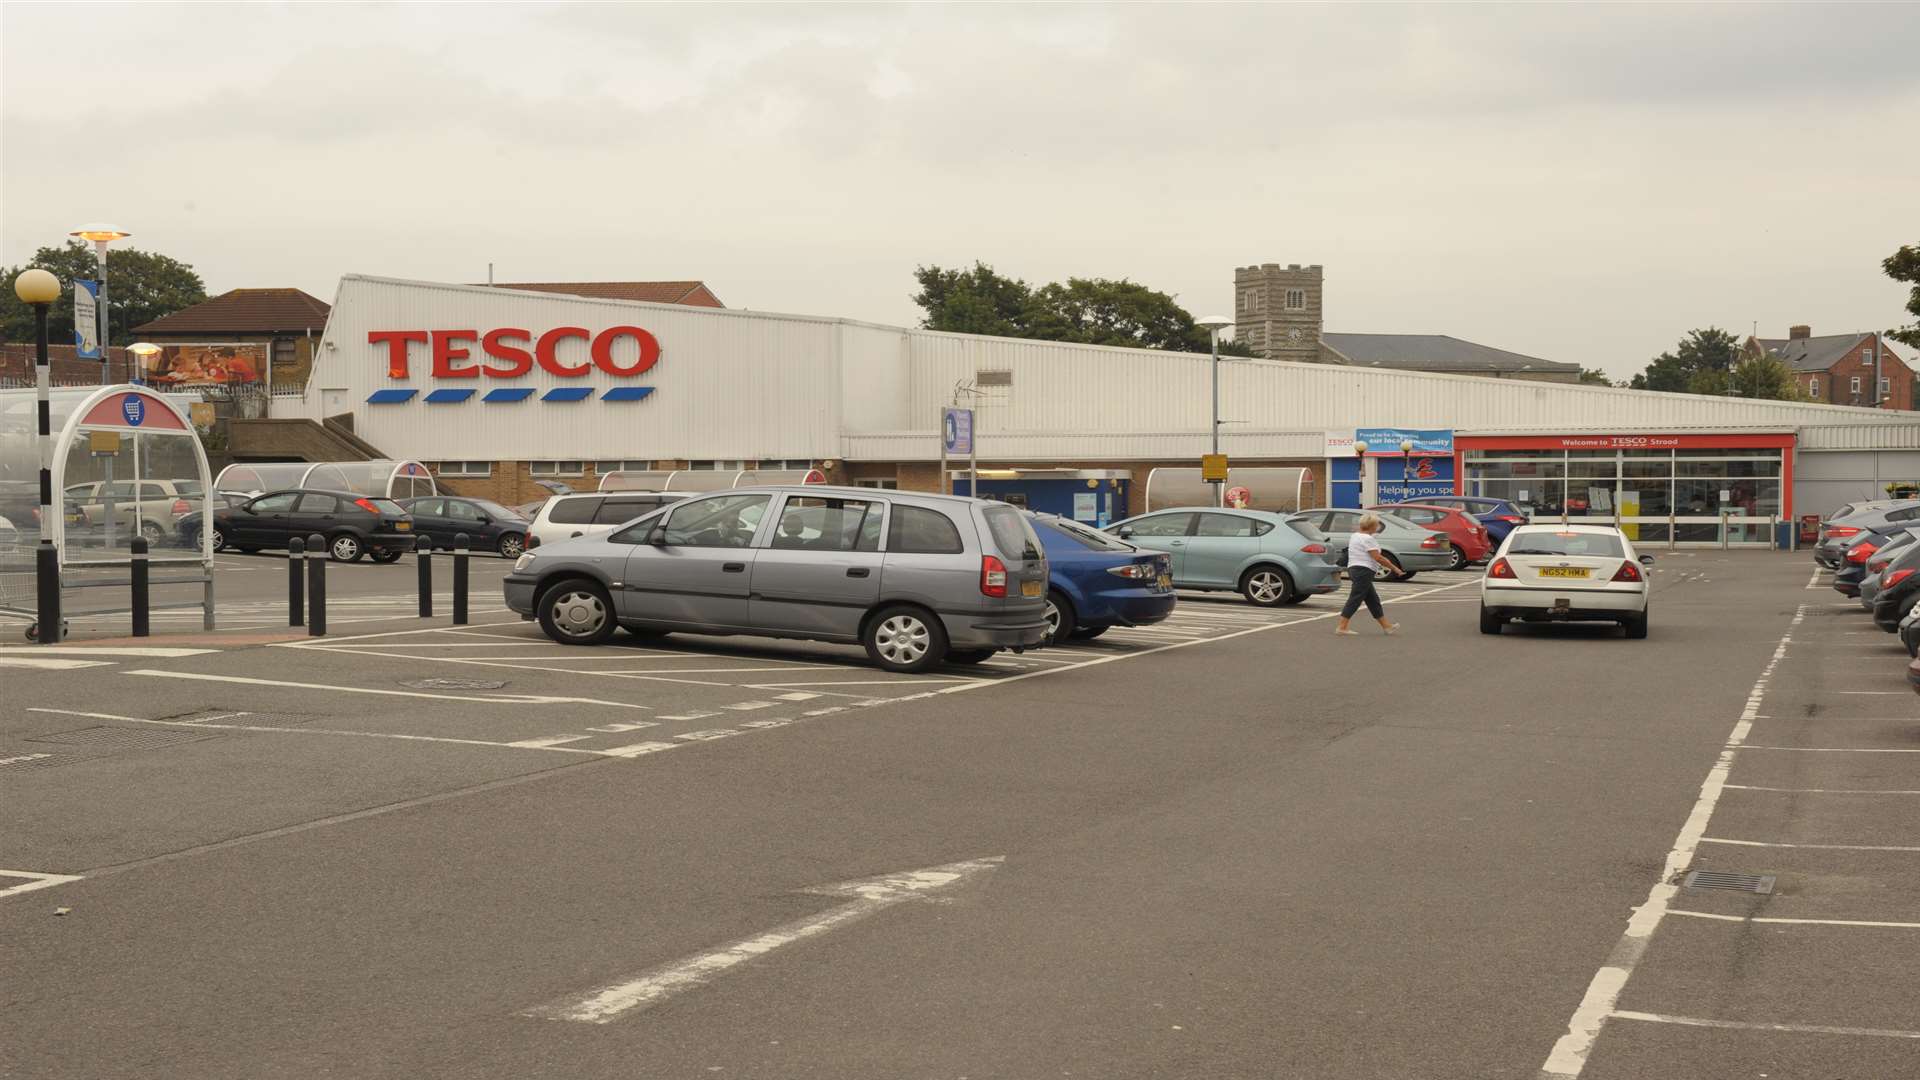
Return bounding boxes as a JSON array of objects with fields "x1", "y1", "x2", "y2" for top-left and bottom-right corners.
[{"x1": 505, "y1": 484, "x2": 1048, "y2": 671}]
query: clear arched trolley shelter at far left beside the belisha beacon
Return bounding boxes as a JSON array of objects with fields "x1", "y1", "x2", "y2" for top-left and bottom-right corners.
[{"x1": 0, "y1": 386, "x2": 213, "y2": 630}]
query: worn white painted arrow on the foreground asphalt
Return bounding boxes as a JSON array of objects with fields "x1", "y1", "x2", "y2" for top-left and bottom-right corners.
[{"x1": 522, "y1": 855, "x2": 1002, "y2": 1024}]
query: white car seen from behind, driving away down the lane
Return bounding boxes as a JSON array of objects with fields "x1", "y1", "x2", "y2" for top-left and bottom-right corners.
[{"x1": 1480, "y1": 525, "x2": 1653, "y2": 638}]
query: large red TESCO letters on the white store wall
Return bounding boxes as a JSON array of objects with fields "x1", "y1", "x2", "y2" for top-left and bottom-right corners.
[{"x1": 367, "y1": 327, "x2": 660, "y2": 379}]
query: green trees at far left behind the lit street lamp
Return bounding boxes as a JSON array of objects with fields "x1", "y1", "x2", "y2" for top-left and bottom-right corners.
[{"x1": 0, "y1": 240, "x2": 207, "y2": 346}]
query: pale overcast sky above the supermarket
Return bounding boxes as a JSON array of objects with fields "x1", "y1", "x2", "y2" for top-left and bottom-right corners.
[{"x1": 0, "y1": 2, "x2": 1920, "y2": 377}]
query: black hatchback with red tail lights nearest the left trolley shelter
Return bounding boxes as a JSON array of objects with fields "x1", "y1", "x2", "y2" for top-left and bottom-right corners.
[{"x1": 213, "y1": 488, "x2": 413, "y2": 563}]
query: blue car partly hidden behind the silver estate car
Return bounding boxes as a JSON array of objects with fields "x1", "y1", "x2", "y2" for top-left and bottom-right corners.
[{"x1": 1027, "y1": 513, "x2": 1175, "y2": 644}]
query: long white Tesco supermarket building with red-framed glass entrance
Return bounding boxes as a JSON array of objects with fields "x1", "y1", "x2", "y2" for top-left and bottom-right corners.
[{"x1": 266, "y1": 275, "x2": 1920, "y2": 544}]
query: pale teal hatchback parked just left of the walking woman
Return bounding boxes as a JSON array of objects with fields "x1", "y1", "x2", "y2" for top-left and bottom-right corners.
[{"x1": 1106, "y1": 507, "x2": 1340, "y2": 607}]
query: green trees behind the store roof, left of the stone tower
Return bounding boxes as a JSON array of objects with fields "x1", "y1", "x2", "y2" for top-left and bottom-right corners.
[{"x1": 914, "y1": 263, "x2": 1254, "y2": 356}]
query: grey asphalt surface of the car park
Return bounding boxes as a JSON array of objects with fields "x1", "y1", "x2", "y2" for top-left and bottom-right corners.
[{"x1": 0, "y1": 552, "x2": 1920, "y2": 1080}]
